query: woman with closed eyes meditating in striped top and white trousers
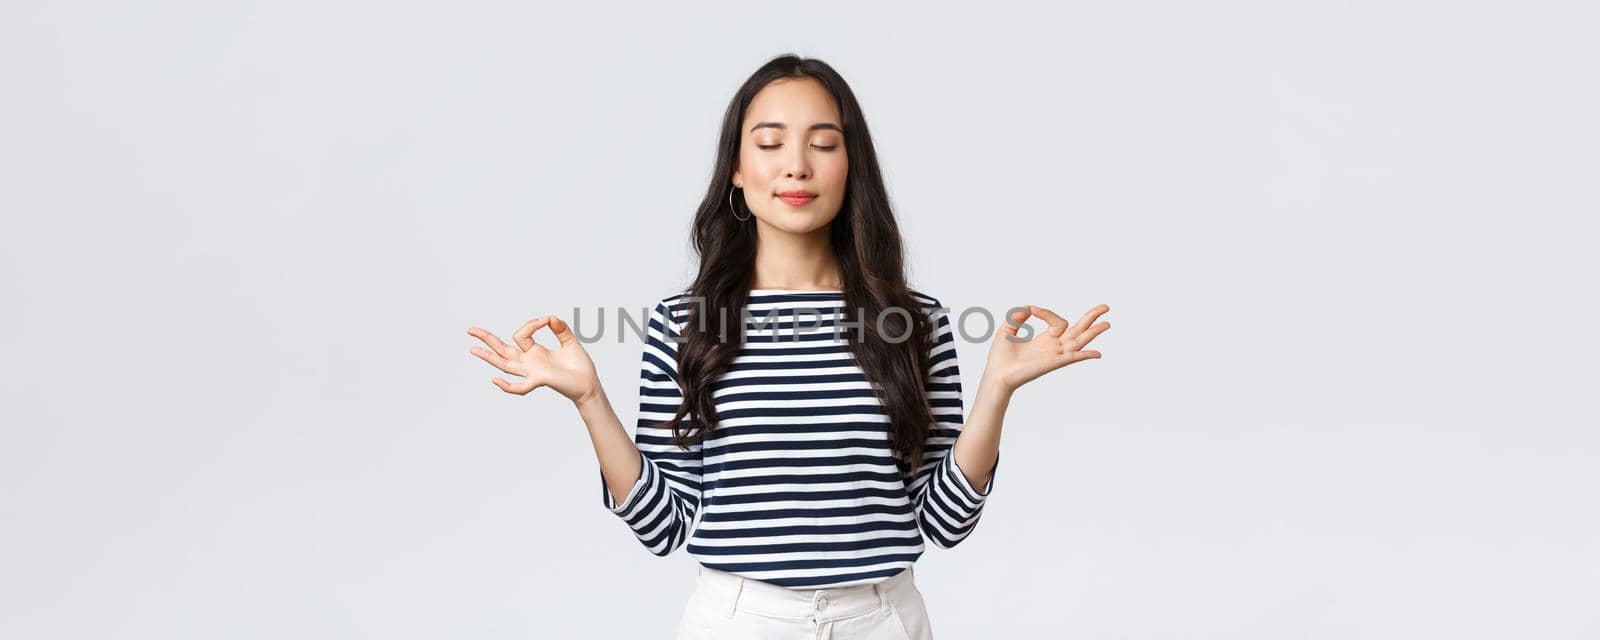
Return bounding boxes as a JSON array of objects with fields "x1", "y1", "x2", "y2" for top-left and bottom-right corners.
[{"x1": 467, "y1": 56, "x2": 1110, "y2": 638}]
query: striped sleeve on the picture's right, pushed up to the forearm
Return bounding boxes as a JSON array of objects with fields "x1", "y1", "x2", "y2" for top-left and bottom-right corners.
[{"x1": 907, "y1": 301, "x2": 1000, "y2": 549}]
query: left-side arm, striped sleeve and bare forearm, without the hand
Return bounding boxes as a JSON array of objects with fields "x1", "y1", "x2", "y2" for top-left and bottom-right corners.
[{"x1": 595, "y1": 301, "x2": 701, "y2": 555}]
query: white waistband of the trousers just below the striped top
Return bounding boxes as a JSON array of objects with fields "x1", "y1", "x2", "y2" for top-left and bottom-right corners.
[{"x1": 696, "y1": 565, "x2": 915, "y2": 621}]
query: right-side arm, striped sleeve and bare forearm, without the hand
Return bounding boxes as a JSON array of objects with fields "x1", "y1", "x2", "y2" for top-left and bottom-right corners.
[{"x1": 909, "y1": 301, "x2": 1005, "y2": 549}]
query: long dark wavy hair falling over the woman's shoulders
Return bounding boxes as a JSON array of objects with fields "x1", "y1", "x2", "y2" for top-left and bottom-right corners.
[{"x1": 664, "y1": 54, "x2": 933, "y2": 477}]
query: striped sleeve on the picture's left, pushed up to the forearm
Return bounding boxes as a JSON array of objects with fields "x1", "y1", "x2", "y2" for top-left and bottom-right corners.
[{"x1": 600, "y1": 299, "x2": 701, "y2": 555}]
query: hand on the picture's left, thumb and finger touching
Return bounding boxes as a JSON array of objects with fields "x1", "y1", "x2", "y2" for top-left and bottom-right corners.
[{"x1": 467, "y1": 315, "x2": 600, "y2": 403}]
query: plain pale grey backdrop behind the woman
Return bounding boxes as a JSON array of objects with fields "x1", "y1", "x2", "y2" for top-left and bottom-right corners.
[{"x1": 0, "y1": 2, "x2": 1600, "y2": 638}]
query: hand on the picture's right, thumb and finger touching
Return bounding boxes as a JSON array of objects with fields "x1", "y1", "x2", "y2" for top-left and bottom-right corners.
[{"x1": 984, "y1": 304, "x2": 1110, "y2": 392}]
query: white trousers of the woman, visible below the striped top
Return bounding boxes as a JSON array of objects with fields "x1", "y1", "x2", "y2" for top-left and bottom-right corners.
[{"x1": 677, "y1": 565, "x2": 933, "y2": 640}]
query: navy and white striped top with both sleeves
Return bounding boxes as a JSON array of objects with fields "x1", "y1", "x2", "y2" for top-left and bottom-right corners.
[{"x1": 600, "y1": 290, "x2": 998, "y2": 589}]
